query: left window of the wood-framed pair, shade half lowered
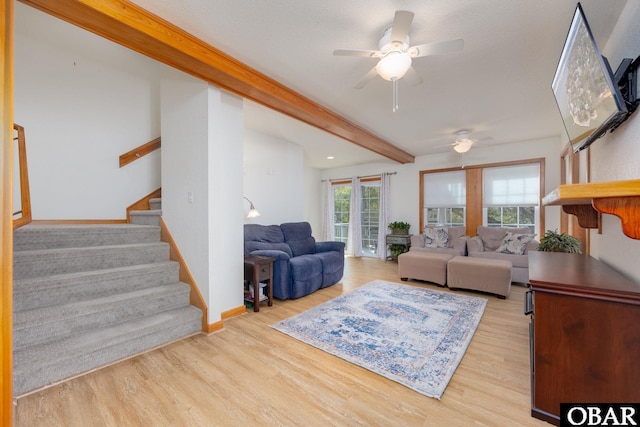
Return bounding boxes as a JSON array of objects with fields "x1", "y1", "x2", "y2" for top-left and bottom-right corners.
[{"x1": 423, "y1": 171, "x2": 466, "y2": 227}]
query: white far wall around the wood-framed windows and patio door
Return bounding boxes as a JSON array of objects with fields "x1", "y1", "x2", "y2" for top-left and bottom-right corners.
[{"x1": 320, "y1": 137, "x2": 560, "y2": 239}]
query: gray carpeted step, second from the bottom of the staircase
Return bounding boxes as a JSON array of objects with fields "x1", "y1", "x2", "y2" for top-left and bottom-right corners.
[{"x1": 13, "y1": 283, "x2": 189, "y2": 349}]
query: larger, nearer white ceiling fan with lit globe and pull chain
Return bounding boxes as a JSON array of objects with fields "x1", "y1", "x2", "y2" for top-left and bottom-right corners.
[{"x1": 333, "y1": 10, "x2": 464, "y2": 112}]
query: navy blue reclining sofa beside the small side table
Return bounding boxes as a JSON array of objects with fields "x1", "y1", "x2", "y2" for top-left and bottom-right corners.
[{"x1": 244, "y1": 222, "x2": 344, "y2": 299}]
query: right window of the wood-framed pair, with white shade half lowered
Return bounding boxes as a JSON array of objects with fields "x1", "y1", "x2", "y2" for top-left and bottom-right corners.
[{"x1": 482, "y1": 163, "x2": 540, "y2": 234}]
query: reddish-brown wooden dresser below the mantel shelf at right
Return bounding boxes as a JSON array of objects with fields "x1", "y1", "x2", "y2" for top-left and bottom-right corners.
[{"x1": 525, "y1": 252, "x2": 640, "y2": 425}]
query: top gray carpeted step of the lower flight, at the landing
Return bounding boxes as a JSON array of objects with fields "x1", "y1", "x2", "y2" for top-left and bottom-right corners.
[{"x1": 13, "y1": 224, "x2": 160, "y2": 252}]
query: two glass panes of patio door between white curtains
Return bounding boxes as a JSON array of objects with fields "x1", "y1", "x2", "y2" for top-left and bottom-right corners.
[{"x1": 333, "y1": 179, "x2": 380, "y2": 256}]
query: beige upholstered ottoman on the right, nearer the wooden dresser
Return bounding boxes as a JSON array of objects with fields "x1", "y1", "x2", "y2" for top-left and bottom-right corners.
[{"x1": 447, "y1": 256, "x2": 511, "y2": 299}]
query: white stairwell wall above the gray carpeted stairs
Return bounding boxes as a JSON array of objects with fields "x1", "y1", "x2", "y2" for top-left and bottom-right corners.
[{"x1": 14, "y1": 3, "x2": 161, "y2": 219}]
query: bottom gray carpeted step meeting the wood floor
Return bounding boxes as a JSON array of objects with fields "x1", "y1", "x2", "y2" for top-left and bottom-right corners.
[{"x1": 13, "y1": 306, "x2": 202, "y2": 396}]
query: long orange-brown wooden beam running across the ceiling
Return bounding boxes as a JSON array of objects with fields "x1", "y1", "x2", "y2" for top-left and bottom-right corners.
[{"x1": 19, "y1": 0, "x2": 415, "y2": 163}]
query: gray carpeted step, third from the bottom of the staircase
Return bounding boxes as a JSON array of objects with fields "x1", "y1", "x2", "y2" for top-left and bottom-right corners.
[{"x1": 13, "y1": 261, "x2": 179, "y2": 312}]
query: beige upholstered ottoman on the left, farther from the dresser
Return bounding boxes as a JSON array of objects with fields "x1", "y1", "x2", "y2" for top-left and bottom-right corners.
[{"x1": 398, "y1": 251, "x2": 454, "y2": 286}]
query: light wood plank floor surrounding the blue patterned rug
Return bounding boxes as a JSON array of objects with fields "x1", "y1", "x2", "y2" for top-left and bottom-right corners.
[{"x1": 15, "y1": 258, "x2": 549, "y2": 427}]
